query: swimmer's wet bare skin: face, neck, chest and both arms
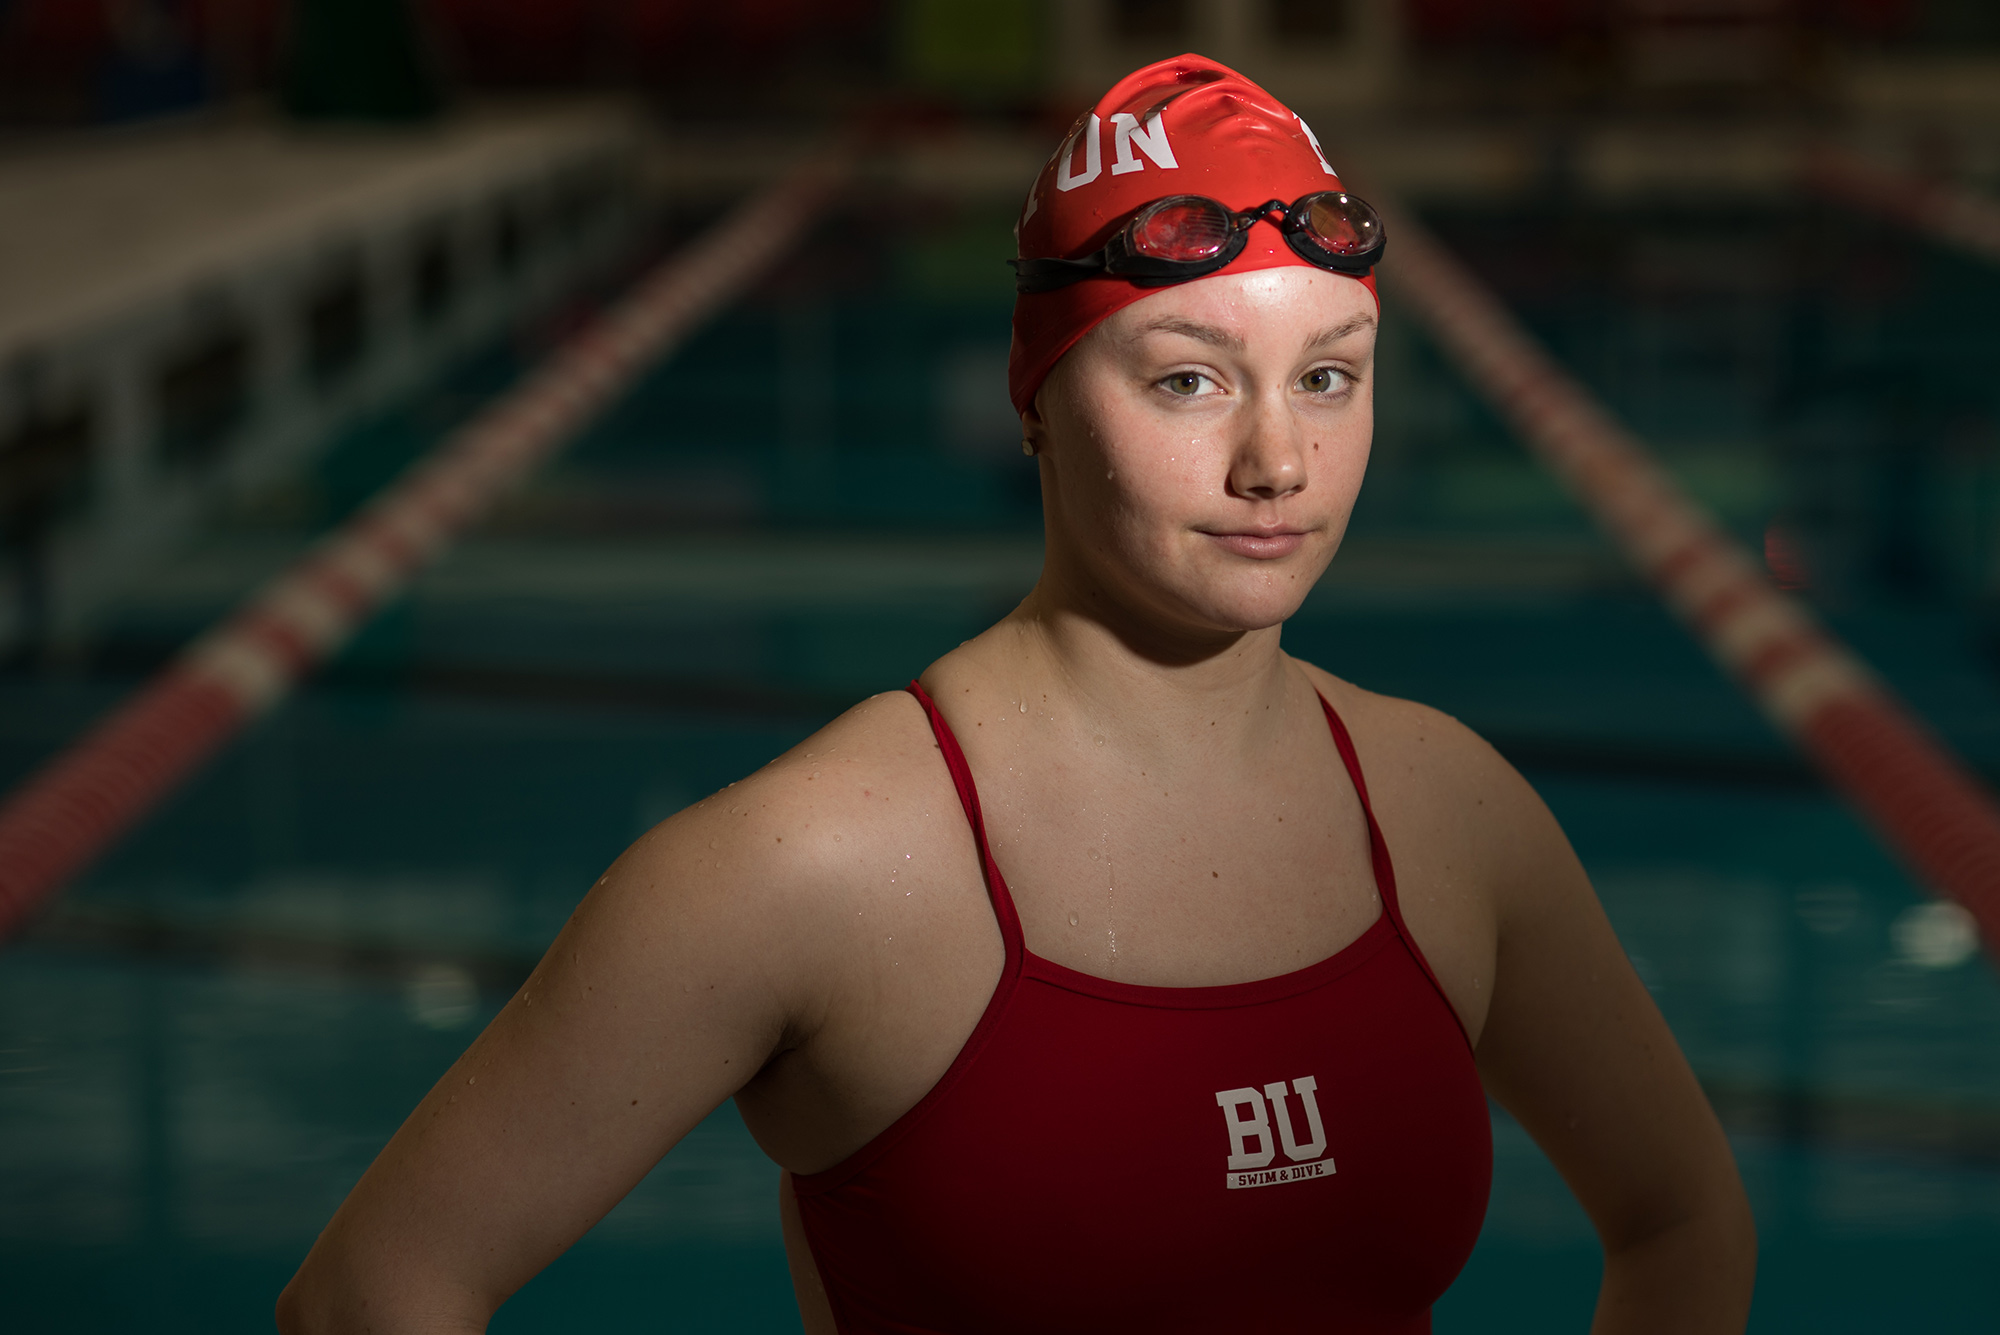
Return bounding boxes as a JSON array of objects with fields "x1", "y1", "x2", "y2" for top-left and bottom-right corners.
[{"x1": 278, "y1": 266, "x2": 1754, "y2": 1333}]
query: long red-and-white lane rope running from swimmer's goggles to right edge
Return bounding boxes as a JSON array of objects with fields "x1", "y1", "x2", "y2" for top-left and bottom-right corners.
[{"x1": 1378, "y1": 192, "x2": 2000, "y2": 957}]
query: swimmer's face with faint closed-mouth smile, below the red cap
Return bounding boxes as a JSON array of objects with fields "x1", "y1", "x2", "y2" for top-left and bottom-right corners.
[{"x1": 1024, "y1": 266, "x2": 1376, "y2": 632}]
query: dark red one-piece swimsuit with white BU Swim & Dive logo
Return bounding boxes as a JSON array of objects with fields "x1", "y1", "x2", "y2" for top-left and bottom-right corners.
[{"x1": 794, "y1": 683, "x2": 1492, "y2": 1335}]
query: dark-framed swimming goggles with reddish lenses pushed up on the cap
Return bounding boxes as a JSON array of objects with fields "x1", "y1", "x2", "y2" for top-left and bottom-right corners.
[{"x1": 1008, "y1": 190, "x2": 1388, "y2": 292}]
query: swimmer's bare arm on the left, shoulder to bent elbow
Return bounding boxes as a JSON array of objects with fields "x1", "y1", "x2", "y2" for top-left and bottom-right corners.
[{"x1": 278, "y1": 705, "x2": 928, "y2": 1335}]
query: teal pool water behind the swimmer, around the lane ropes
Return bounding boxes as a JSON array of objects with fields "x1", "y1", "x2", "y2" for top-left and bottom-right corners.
[{"x1": 0, "y1": 192, "x2": 2000, "y2": 1333}]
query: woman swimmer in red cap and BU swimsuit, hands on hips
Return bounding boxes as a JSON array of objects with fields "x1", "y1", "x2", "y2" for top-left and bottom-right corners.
[{"x1": 278, "y1": 56, "x2": 1754, "y2": 1335}]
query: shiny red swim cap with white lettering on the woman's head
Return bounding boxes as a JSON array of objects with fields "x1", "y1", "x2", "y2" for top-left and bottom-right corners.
[{"x1": 1006, "y1": 56, "x2": 1380, "y2": 412}]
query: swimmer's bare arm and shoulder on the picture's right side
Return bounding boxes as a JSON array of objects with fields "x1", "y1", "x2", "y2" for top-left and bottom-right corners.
[{"x1": 1336, "y1": 687, "x2": 1756, "y2": 1335}]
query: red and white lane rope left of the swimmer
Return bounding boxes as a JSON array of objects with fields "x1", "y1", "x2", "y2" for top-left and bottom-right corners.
[{"x1": 0, "y1": 144, "x2": 856, "y2": 939}]
